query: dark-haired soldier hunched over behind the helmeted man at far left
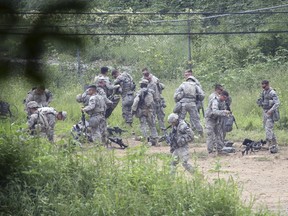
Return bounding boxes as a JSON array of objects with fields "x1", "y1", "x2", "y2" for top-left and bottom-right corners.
[{"x1": 24, "y1": 86, "x2": 52, "y2": 116}]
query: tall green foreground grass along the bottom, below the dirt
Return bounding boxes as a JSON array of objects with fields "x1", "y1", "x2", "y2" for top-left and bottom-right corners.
[{"x1": 0, "y1": 124, "x2": 270, "y2": 216}]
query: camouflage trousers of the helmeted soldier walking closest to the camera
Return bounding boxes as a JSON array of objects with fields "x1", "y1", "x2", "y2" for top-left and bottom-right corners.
[{"x1": 171, "y1": 145, "x2": 193, "y2": 174}]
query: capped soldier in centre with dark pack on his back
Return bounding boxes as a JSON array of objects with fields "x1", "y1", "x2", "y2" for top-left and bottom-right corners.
[{"x1": 132, "y1": 79, "x2": 158, "y2": 146}]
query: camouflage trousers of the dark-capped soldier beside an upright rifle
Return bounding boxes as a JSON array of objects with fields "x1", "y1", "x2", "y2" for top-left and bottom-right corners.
[{"x1": 89, "y1": 114, "x2": 107, "y2": 145}]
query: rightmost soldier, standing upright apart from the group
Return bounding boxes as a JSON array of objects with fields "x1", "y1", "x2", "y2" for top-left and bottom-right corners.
[{"x1": 257, "y1": 80, "x2": 280, "y2": 153}]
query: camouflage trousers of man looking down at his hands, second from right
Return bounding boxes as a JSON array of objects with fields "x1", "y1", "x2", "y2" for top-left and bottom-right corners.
[{"x1": 206, "y1": 118, "x2": 224, "y2": 153}]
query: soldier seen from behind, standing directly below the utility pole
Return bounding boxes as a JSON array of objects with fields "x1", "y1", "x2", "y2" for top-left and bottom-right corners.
[{"x1": 174, "y1": 76, "x2": 205, "y2": 136}]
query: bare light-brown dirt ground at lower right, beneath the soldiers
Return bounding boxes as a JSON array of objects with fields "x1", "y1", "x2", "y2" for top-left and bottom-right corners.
[{"x1": 114, "y1": 139, "x2": 288, "y2": 215}]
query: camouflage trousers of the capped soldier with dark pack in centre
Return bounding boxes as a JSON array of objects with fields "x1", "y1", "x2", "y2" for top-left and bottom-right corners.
[{"x1": 139, "y1": 112, "x2": 158, "y2": 139}]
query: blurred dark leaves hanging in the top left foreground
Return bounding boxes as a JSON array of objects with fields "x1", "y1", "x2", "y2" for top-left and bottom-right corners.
[{"x1": 0, "y1": 0, "x2": 86, "y2": 84}]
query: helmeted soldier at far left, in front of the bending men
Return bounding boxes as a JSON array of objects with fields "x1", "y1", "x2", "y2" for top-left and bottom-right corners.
[{"x1": 27, "y1": 101, "x2": 49, "y2": 137}]
